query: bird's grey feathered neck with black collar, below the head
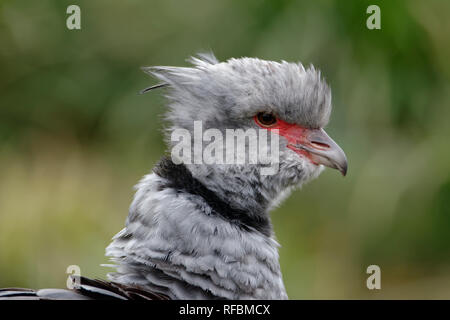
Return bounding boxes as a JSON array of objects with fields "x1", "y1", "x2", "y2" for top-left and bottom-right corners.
[{"x1": 107, "y1": 159, "x2": 287, "y2": 299}]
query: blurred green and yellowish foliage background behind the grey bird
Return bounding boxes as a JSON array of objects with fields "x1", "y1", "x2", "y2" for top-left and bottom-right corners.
[{"x1": 0, "y1": 0, "x2": 450, "y2": 299}]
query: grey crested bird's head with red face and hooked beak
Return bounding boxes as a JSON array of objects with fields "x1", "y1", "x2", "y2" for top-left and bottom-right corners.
[{"x1": 143, "y1": 54, "x2": 347, "y2": 198}]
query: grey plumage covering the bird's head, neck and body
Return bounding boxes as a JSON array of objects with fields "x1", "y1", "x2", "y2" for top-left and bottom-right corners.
[{"x1": 0, "y1": 54, "x2": 347, "y2": 299}]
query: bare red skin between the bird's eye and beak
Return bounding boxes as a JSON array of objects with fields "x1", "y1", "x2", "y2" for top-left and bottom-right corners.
[{"x1": 253, "y1": 116, "x2": 318, "y2": 165}]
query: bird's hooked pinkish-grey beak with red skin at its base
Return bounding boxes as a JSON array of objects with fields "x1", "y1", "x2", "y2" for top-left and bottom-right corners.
[{"x1": 287, "y1": 128, "x2": 347, "y2": 176}]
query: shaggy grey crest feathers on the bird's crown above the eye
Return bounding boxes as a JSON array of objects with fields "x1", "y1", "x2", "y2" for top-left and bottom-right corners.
[{"x1": 143, "y1": 53, "x2": 331, "y2": 129}]
